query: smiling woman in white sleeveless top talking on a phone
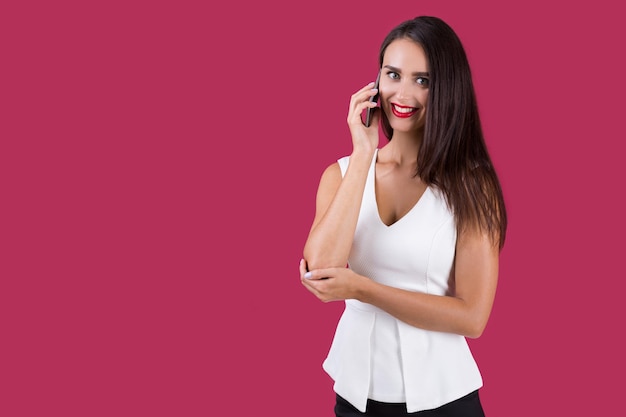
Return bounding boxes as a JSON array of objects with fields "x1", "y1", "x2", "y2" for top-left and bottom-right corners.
[{"x1": 300, "y1": 16, "x2": 506, "y2": 416}]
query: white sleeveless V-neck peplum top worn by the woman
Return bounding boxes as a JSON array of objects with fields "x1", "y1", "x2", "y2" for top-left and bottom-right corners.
[{"x1": 323, "y1": 152, "x2": 482, "y2": 413}]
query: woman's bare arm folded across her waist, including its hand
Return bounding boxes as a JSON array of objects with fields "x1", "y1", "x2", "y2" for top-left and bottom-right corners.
[{"x1": 301, "y1": 226, "x2": 499, "y2": 338}]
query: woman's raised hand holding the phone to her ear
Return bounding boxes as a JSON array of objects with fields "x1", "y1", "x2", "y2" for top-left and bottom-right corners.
[{"x1": 347, "y1": 82, "x2": 380, "y2": 158}]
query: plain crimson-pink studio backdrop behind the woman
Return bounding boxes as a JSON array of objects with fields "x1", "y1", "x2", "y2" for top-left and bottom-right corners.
[{"x1": 0, "y1": 0, "x2": 626, "y2": 417}]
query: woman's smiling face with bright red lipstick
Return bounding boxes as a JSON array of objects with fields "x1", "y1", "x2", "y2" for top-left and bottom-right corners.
[{"x1": 379, "y1": 39, "x2": 430, "y2": 133}]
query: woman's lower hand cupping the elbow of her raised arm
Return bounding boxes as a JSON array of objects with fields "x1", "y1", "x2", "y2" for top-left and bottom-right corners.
[{"x1": 300, "y1": 260, "x2": 366, "y2": 303}]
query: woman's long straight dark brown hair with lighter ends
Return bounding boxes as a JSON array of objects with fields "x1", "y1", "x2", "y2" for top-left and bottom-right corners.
[{"x1": 379, "y1": 16, "x2": 507, "y2": 249}]
